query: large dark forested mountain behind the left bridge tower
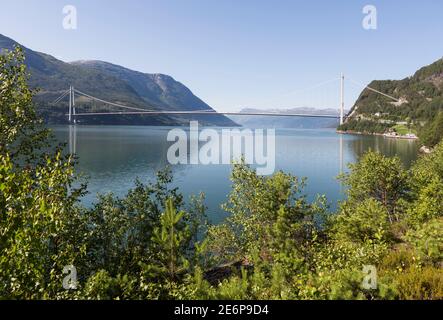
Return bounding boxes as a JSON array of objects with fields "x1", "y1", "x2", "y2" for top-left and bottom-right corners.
[{"x1": 0, "y1": 34, "x2": 236, "y2": 126}]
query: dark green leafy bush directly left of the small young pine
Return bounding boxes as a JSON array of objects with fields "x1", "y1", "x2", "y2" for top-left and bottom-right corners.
[{"x1": 78, "y1": 170, "x2": 183, "y2": 276}]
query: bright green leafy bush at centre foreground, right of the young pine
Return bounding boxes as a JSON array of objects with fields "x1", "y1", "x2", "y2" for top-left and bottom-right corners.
[{"x1": 208, "y1": 163, "x2": 325, "y2": 268}]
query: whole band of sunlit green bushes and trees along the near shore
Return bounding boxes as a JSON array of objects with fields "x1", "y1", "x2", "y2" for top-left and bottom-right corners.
[{"x1": 0, "y1": 49, "x2": 443, "y2": 300}]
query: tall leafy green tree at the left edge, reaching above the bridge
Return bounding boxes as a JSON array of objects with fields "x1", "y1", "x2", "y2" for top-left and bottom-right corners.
[{"x1": 0, "y1": 49, "x2": 85, "y2": 299}]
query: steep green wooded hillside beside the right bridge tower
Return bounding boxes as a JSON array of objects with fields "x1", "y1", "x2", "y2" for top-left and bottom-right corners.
[{"x1": 339, "y1": 59, "x2": 443, "y2": 146}]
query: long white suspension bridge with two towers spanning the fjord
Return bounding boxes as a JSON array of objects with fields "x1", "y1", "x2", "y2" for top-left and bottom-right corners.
[{"x1": 53, "y1": 74, "x2": 399, "y2": 124}]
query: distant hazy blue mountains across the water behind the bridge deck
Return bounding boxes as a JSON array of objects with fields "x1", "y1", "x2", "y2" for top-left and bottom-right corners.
[{"x1": 229, "y1": 108, "x2": 339, "y2": 129}]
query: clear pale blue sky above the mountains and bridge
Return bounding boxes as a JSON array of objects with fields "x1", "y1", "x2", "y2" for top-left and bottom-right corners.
[{"x1": 0, "y1": 0, "x2": 443, "y2": 111}]
